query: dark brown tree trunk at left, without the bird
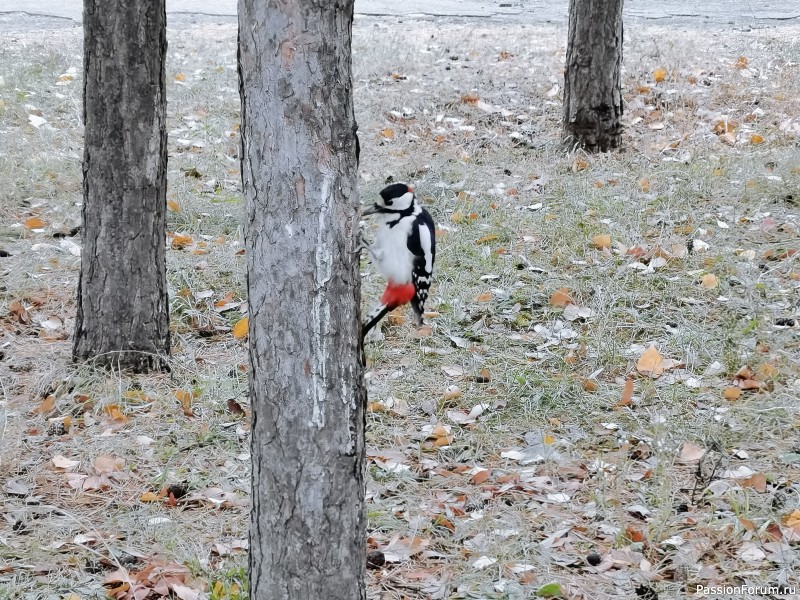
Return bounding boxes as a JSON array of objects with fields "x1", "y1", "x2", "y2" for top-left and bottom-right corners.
[{"x1": 73, "y1": 0, "x2": 169, "y2": 371}]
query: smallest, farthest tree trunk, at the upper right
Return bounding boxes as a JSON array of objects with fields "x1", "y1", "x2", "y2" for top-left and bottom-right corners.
[{"x1": 563, "y1": 0, "x2": 622, "y2": 152}]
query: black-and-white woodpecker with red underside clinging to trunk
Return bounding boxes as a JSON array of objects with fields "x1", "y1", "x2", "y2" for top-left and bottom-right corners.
[{"x1": 361, "y1": 183, "x2": 436, "y2": 339}]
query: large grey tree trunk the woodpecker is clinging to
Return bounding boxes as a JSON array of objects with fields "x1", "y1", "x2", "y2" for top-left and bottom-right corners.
[{"x1": 239, "y1": 0, "x2": 366, "y2": 600}]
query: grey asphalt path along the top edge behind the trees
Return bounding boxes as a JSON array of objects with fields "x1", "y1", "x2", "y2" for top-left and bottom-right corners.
[{"x1": 0, "y1": 0, "x2": 800, "y2": 32}]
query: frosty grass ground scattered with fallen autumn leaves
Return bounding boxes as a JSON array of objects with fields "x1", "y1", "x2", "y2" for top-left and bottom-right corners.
[{"x1": 0, "y1": 18, "x2": 800, "y2": 600}]
